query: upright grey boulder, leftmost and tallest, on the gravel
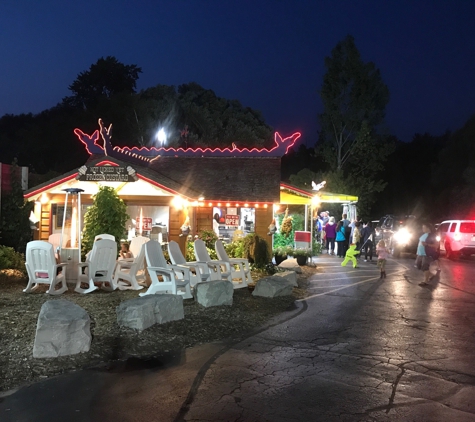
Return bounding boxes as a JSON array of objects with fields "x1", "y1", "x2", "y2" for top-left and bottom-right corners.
[{"x1": 33, "y1": 299, "x2": 91, "y2": 358}]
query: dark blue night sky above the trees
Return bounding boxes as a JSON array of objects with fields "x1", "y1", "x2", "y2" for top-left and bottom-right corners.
[{"x1": 0, "y1": 0, "x2": 475, "y2": 146}]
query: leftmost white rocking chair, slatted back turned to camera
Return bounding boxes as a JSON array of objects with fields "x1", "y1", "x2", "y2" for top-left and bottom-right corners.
[{"x1": 23, "y1": 240, "x2": 68, "y2": 295}]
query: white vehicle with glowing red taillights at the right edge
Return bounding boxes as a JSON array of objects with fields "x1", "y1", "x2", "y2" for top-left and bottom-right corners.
[{"x1": 437, "y1": 220, "x2": 475, "y2": 259}]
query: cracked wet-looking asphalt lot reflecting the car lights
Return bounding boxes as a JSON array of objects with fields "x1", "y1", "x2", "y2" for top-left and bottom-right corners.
[{"x1": 0, "y1": 257, "x2": 475, "y2": 422}]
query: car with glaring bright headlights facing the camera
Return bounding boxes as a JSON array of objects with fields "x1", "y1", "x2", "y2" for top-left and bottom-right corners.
[{"x1": 377, "y1": 215, "x2": 422, "y2": 258}]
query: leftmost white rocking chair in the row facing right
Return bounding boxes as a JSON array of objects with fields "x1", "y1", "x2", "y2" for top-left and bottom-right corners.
[{"x1": 139, "y1": 240, "x2": 193, "y2": 299}]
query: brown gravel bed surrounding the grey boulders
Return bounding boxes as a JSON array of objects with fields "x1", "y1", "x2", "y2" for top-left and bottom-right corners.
[{"x1": 0, "y1": 267, "x2": 317, "y2": 391}]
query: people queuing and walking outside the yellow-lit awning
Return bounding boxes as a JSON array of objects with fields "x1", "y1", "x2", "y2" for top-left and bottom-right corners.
[{"x1": 315, "y1": 211, "x2": 440, "y2": 286}]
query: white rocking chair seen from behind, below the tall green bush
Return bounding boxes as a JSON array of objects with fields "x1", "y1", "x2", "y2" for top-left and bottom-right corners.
[{"x1": 74, "y1": 239, "x2": 117, "y2": 293}]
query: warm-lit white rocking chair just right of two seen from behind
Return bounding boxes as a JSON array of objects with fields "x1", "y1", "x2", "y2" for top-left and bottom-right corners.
[{"x1": 114, "y1": 236, "x2": 150, "y2": 290}]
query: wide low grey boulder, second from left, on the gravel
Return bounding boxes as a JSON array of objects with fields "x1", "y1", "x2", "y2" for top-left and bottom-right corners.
[{"x1": 116, "y1": 294, "x2": 185, "y2": 331}]
